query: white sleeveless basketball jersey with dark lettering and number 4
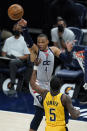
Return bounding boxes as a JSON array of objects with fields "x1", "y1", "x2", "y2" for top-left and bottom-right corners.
[{"x1": 37, "y1": 48, "x2": 54, "y2": 82}]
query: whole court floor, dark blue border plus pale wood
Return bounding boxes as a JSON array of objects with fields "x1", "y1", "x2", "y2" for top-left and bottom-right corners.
[{"x1": 0, "y1": 92, "x2": 87, "y2": 131}]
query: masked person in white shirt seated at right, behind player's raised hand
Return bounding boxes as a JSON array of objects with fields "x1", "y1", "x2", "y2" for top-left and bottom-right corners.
[{"x1": 51, "y1": 17, "x2": 75, "y2": 50}]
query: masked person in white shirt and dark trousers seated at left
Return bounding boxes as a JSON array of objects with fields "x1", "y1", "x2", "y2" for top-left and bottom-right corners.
[{"x1": 0, "y1": 24, "x2": 32, "y2": 90}]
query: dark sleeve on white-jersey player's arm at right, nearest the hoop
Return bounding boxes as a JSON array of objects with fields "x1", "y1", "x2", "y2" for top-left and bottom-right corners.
[{"x1": 59, "y1": 50, "x2": 73, "y2": 63}]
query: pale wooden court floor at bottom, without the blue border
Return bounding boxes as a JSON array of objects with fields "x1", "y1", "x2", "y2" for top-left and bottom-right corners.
[{"x1": 0, "y1": 110, "x2": 87, "y2": 131}]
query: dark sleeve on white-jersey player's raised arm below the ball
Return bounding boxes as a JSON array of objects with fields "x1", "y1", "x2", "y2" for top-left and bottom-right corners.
[{"x1": 22, "y1": 27, "x2": 34, "y2": 48}]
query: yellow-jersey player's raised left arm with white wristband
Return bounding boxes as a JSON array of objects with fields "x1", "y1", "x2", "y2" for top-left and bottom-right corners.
[{"x1": 30, "y1": 66, "x2": 48, "y2": 97}]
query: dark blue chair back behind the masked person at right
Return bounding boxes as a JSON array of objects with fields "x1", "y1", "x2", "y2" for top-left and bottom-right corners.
[{"x1": 68, "y1": 27, "x2": 84, "y2": 45}]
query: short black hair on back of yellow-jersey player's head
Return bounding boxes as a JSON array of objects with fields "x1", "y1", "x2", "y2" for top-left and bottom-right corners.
[{"x1": 50, "y1": 75, "x2": 62, "y2": 91}]
